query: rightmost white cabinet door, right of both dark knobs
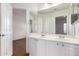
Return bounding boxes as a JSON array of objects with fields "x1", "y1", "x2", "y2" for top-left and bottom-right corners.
[{"x1": 65, "y1": 44, "x2": 79, "y2": 56}]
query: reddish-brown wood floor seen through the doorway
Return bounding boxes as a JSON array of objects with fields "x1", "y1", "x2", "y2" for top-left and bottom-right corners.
[{"x1": 13, "y1": 38, "x2": 29, "y2": 56}]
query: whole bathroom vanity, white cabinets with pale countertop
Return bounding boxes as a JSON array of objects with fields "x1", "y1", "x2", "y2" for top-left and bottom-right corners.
[{"x1": 29, "y1": 33, "x2": 79, "y2": 56}]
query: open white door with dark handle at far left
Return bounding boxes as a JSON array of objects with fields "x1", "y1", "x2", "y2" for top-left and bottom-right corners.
[{"x1": 0, "y1": 3, "x2": 12, "y2": 56}]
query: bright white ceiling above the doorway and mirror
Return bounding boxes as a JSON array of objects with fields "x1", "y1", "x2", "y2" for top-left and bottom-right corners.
[{"x1": 11, "y1": 3, "x2": 69, "y2": 13}]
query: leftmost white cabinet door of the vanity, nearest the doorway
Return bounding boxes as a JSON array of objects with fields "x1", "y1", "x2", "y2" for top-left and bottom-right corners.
[{"x1": 29, "y1": 39, "x2": 38, "y2": 56}]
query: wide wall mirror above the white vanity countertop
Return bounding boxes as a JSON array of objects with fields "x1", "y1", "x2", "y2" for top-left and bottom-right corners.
[{"x1": 31, "y1": 4, "x2": 79, "y2": 36}]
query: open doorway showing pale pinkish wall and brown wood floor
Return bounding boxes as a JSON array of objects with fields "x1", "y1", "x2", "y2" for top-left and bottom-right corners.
[{"x1": 13, "y1": 8, "x2": 27, "y2": 56}]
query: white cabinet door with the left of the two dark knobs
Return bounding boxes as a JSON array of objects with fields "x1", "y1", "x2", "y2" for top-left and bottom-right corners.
[{"x1": 46, "y1": 41, "x2": 63, "y2": 56}]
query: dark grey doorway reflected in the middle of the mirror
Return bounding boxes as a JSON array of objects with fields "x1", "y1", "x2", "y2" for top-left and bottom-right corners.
[{"x1": 55, "y1": 16, "x2": 67, "y2": 34}]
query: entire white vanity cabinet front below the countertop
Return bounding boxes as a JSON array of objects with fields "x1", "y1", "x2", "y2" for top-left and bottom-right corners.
[{"x1": 29, "y1": 38, "x2": 79, "y2": 56}]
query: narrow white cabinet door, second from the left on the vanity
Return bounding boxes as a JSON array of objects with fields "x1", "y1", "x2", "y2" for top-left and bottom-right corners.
[{"x1": 37, "y1": 39, "x2": 46, "y2": 56}]
